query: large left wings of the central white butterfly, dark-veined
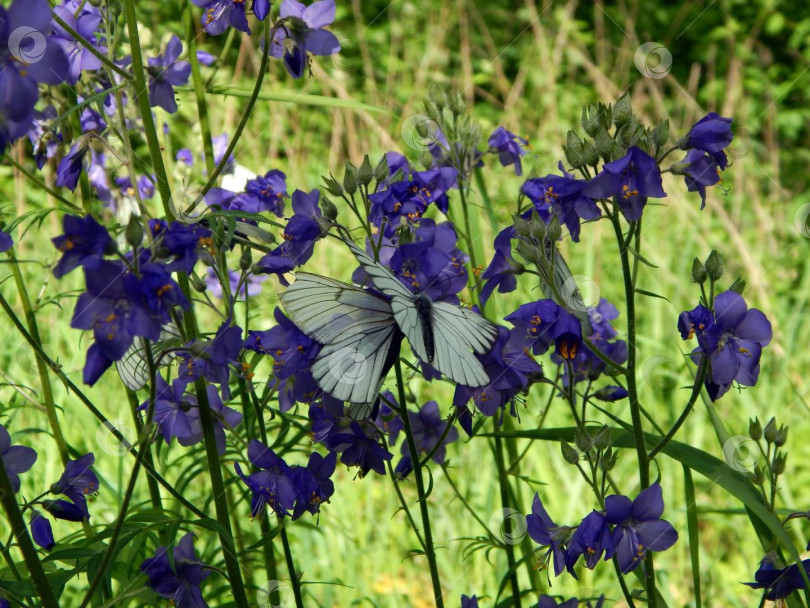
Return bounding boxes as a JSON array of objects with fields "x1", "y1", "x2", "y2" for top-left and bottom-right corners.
[{"x1": 279, "y1": 272, "x2": 396, "y2": 403}]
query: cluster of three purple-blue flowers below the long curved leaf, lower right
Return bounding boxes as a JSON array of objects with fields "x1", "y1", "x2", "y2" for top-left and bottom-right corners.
[{"x1": 526, "y1": 482, "x2": 678, "y2": 578}]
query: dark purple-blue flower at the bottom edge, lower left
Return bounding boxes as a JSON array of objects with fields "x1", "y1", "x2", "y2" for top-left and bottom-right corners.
[{"x1": 141, "y1": 532, "x2": 211, "y2": 608}]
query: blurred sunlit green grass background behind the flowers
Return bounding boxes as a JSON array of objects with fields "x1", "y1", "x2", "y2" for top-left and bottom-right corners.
[{"x1": 0, "y1": 0, "x2": 810, "y2": 608}]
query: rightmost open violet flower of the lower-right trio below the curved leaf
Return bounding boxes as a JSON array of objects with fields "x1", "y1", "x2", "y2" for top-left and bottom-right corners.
[{"x1": 605, "y1": 482, "x2": 678, "y2": 574}]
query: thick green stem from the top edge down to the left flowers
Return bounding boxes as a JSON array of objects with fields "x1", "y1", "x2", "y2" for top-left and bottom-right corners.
[{"x1": 123, "y1": 0, "x2": 175, "y2": 219}]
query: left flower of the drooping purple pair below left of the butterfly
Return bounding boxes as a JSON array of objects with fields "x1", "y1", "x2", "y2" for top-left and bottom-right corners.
[{"x1": 234, "y1": 439, "x2": 298, "y2": 517}]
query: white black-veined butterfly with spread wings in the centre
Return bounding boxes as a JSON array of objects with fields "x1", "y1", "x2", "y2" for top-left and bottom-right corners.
[{"x1": 279, "y1": 241, "x2": 498, "y2": 403}]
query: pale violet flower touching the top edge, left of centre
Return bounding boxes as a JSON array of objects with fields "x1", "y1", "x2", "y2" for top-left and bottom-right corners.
[{"x1": 270, "y1": 0, "x2": 340, "y2": 78}]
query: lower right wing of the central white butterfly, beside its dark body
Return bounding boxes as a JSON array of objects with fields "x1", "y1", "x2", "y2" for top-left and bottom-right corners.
[{"x1": 432, "y1": 302, "x2": 498, "y2": 386}]
